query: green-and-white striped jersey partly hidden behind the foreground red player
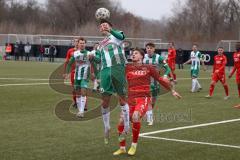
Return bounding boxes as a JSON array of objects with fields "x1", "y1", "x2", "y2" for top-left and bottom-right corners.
[{"x1": 143, "y1": 53, "x2": 171, "y2": 76}]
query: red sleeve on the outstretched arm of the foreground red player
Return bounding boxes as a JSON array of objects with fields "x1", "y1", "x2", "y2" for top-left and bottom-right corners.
[{"x1": 149, "y1": 66, "x2": 171, "y2": 90}]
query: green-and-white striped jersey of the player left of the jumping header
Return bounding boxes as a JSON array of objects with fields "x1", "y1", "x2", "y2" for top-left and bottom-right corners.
[{"x1": 67, "y1": 50, "x2": 91, "y2": 80}]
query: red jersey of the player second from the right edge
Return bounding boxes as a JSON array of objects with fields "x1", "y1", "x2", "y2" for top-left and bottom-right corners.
[{"x1": 213, "y1": 55, "x2": 227, "y2": 74}]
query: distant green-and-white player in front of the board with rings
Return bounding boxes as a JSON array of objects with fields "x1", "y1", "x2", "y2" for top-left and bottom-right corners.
[{"x1": 184, "y1": 44, "x2": 206, "y2": 93}]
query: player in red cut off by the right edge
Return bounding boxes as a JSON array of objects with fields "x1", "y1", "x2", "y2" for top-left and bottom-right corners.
[{"x1": 229, "y1": 43, "x2": 240, "y2": 98}]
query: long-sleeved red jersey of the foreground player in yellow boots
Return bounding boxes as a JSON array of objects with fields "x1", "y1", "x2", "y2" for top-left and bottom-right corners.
[{"x1": 126, "y1": 64, "x2": 170, "y2": 99}]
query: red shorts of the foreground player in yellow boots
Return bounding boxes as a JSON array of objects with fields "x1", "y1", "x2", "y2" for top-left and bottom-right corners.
[{"x1": 129, "y1": 97, "x2": 151, "y2": 117}]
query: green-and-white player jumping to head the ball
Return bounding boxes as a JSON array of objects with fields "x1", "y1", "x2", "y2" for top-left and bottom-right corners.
[{"x1": 90, "y1": 20, "x2": 129, "y2": 144}]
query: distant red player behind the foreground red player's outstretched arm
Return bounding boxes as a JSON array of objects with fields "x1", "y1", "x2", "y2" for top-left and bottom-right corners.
[{"x1": 167, "y1": 42, "x2": 177, "y2": 82}]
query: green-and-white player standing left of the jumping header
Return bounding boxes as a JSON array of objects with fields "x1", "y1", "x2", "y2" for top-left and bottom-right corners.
[{"x1": 66, "y1": 38, "x2": 90, "y2": 118}]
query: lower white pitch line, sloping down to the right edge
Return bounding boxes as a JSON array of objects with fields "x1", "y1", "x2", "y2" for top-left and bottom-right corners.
[{"x1": 141, "y1": 136, "x2": 240, "y2": 149}]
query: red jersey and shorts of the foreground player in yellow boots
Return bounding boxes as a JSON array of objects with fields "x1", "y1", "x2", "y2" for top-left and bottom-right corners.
[{"x1": 126, "y1": 64, "x2": 170, "y2": 117}]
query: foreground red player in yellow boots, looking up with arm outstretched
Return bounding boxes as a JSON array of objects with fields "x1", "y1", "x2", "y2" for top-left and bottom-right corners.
[{"x1": 113, "y1": 49, "x2": 181, "y2": 155}]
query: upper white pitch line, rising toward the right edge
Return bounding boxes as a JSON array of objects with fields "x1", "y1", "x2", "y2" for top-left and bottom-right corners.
[{"x1": 140, "y1": 119, "x2": 240, "y2": 136}]
